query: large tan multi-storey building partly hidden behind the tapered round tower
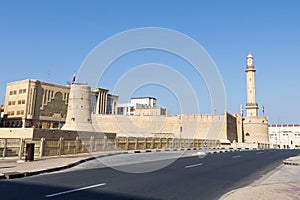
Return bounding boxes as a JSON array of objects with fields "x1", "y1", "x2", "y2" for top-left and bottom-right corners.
[{"x1": 3, "y1": 79, "x2": 118, "y2": 128}]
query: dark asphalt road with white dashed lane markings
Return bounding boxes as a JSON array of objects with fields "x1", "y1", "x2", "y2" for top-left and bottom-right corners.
[{"x1": 0, "y1": 150, "x2": 300, "y2": 200}]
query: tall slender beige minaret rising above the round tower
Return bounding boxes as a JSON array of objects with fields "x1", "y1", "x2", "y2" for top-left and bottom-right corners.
[{"x1": 245, "y1": 53, "x2": 258, "y2": 117}]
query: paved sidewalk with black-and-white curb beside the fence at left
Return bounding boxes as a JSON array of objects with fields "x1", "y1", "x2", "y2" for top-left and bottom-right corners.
[{"x1": 0, "y1": 151, "x2": 128, "y2": 179}]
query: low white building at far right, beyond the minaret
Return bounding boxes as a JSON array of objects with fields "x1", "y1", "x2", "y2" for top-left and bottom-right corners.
[{"x1": 269, "y1": 124, "x2": 300, "y2": 149}]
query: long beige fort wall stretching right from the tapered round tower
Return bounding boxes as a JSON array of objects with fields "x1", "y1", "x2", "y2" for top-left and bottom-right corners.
[{"x1": 93, "y1": 114, "x2": 230, "y2": 139}]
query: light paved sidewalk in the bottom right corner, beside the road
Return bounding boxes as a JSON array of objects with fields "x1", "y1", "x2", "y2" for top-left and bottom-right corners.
[{"x1": 220, "y1": 155, "x2": 300, "y2": 200}]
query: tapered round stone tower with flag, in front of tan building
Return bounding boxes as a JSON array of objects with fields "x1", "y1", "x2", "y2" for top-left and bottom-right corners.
[{"x1": 62, "y1": 84, "x2": 94, "y2": 132}]
